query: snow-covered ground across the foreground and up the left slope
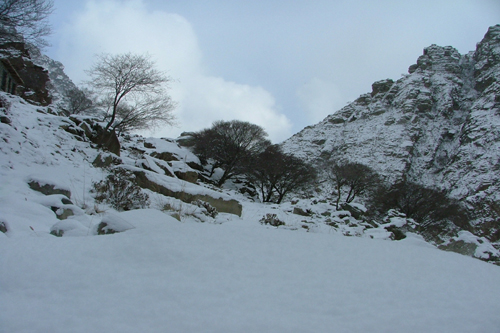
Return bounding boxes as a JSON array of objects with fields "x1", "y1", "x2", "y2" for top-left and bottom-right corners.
[{"x1": 0, "y1": 91, "x2": 500, "y2": 333}]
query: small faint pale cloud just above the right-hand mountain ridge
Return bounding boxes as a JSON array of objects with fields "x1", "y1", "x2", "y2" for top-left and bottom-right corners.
[{"x1": 297, "y1": 77, "x2": 343, "y2": 123}]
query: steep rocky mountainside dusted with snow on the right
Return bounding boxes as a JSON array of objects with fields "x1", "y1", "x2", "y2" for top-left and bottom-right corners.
[{"x1": 283, "y1": 25, "x2": 500, "y2": 241}]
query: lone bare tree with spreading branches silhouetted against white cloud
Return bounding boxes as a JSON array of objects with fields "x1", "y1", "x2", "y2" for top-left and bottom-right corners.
[{"x1": 86, "y1": 53, "x2": 175, "y2": 131}]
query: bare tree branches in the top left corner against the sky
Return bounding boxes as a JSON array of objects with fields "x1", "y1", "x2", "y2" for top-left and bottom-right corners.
[{"x1": 0, "y1": 0, "x2": 54, "y2": 47}]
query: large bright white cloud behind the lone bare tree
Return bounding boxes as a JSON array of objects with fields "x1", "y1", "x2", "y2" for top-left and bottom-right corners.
[{"x1": 55, "y1": 0, "x2": 292, "y2": 142}]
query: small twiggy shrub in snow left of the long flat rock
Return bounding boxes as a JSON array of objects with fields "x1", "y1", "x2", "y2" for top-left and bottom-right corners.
[{"x1": 91, "y1": 169, "x2": 149, "y2": 211}]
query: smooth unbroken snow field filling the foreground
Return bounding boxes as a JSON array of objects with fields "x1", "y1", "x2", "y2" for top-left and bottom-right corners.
[{"x1": 0, "y1": 210, "x2": 500, "y2": 332}]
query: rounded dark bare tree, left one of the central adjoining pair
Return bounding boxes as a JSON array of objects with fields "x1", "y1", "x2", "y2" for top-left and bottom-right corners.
[{"x1": 193, "y1": 120, "x2": 271, "y2": 186}]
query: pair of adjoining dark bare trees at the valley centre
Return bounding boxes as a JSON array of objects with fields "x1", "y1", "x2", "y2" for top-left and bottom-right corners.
[{"x1": 193, "y1": 120, "x2": 316, "y2": 203}]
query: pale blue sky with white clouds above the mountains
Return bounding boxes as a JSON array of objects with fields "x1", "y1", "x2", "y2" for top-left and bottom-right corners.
[{"x1": 45, "y1": 0, "x2": 500, "y2": 143}]
